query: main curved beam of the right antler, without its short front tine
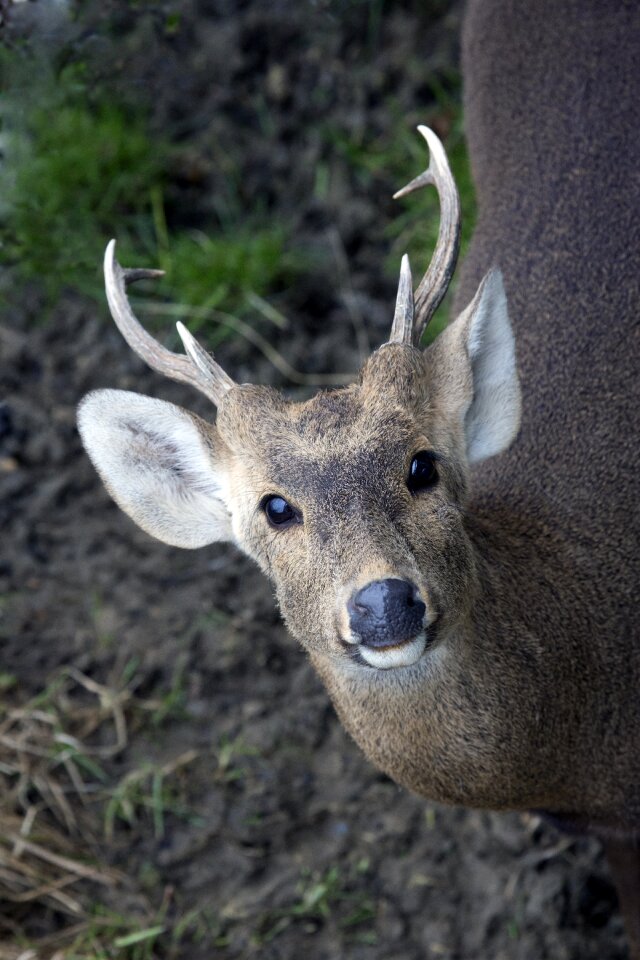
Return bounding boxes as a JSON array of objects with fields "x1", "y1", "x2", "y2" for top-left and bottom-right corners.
[{"x1": 394, "y1": 126, "x2": 460, "y2": 344}]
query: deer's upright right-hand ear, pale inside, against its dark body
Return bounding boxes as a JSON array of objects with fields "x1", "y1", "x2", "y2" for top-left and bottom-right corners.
[{"x1": 425, "y1": 270, "x2": 521, "y2": 463}]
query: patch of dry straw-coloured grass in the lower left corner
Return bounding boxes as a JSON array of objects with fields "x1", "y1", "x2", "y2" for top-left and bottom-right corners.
[{"x1": 0, "y1": 669, "x2": 196, "y2": 960}]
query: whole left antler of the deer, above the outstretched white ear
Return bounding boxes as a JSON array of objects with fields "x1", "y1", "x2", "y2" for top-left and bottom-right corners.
[{"x1": 104, "y1": 240, "x2": 235, "y2": 404}]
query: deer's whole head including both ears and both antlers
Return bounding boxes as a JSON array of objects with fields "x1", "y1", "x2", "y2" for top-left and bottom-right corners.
[{"x1": 79, "y1": 127, "x2": 520, "y2": 673}]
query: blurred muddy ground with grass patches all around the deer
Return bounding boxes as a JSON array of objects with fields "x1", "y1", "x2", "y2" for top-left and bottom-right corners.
[{"x1": 0, "y1": 0, "x2": 625, "y2": 960}]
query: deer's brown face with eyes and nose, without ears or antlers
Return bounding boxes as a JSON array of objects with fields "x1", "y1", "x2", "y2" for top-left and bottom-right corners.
[{"x1": 212, "y1": 345, "x2": 469, "y2": 668}]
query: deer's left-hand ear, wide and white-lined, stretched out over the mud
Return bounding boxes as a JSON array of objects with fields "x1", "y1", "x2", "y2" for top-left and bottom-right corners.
[{"x1": 78, "y1": 390, "x2": 233, "y2": 547}]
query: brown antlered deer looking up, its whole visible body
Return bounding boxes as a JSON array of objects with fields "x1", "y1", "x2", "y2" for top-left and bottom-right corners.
[{"x1": 78, "y1": 0, "x2": 640, "y2": 948}]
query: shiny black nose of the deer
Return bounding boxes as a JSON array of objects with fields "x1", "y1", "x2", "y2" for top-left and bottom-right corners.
[{"x1": 347, "y1": 577, "x2": 427, "y2": 649}]
